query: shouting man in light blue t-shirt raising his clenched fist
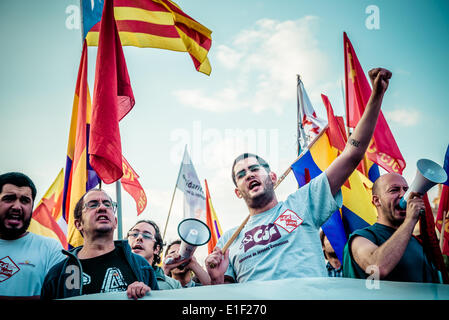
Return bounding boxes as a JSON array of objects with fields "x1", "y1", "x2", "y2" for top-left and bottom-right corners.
[{"x1": 205, "y1": 68, "x2": 392, "y2": 284}]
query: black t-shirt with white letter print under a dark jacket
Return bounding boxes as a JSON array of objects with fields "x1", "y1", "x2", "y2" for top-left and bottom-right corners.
[{"x1": 80, "y1": 248, "x2": 137, "y2": 294}]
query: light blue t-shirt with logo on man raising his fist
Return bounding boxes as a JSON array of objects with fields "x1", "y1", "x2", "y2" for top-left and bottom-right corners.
[{"x1": 217, "y1": 172, "x2": 343, "y2": 282}]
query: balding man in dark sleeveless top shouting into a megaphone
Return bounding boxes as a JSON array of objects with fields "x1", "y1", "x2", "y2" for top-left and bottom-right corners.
[{"x1": 343, "y1": 173, "x2": 440, "y2": 283}]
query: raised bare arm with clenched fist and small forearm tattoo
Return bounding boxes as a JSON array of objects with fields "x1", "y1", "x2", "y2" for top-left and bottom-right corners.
[{"x1": 326, "y1": 68, "x2": 391, "y2": 195}]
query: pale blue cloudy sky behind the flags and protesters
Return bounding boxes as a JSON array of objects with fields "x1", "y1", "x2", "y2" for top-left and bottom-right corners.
[{"x1": 0, "y1": 0, "x2": 449, "y2": 260}]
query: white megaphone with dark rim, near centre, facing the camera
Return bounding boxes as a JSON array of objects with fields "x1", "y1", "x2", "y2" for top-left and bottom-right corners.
[{"x1": 165, "y1": 218, "x2": 211, "y2": 269}]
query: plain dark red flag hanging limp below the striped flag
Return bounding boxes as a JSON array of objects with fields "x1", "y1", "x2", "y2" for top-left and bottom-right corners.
[{"x1": 89, "y1": 0, "x2": 134, "y2": 183}]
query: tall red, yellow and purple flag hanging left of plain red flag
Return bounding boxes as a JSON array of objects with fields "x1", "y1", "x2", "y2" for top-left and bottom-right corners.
[{"x1": 62, "y1": 42, "x2": 99, "y2": 247}]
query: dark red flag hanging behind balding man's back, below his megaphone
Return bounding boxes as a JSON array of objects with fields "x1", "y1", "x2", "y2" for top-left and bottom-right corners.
[{"x1": 419, "y1": 193, "x2": 449, "y2": 284}]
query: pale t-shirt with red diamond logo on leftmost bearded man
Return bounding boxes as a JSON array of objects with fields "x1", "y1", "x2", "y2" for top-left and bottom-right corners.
[{"x1": 0, "y1": 232, "x2": 66, "y2": 296}]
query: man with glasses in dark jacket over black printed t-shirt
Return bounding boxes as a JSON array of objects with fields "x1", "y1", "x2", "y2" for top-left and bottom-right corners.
[{"x1": 41, "y1": 189, "x2": 159, "y2": 299}]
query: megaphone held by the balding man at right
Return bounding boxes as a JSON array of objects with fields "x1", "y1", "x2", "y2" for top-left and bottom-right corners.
[{"x1": 399, "y1": 159, "x2": 447, "y2": 209}]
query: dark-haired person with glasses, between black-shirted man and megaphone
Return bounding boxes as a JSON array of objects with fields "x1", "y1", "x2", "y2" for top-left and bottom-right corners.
[{"x1": 128, "y1": 220, "x2": 182, "y2": 290}]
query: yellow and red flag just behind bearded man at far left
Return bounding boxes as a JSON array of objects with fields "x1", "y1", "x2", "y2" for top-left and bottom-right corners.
[{"x1": 28, "y1": 169, "x2": 68, "y2": 249}]
